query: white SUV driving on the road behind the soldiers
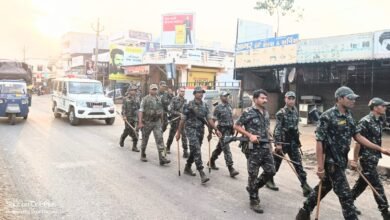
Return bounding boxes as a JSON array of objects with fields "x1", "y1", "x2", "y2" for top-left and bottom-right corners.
[{"x1": 52, "y1": 78, "x2": 115, "y2": 125}]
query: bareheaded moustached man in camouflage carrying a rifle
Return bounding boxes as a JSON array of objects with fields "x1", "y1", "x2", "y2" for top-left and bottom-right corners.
[{"x1": 234, "y1": 89, "x2": 275, "y2": 213}]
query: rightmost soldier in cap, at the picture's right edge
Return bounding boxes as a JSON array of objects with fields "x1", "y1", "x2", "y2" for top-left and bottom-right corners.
[{"x1": 352, "y1": 98, "x2": 390, "y2": 220}]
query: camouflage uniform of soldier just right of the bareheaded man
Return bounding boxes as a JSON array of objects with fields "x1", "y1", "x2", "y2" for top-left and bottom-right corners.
[{"x1": 274, "y1": 106, "x2": 310, "y2": 190}]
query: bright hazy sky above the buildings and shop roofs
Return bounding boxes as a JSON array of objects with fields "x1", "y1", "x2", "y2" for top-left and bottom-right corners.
[{"x1": 0, "y1": 0, "x2": 390, "y2": 59}]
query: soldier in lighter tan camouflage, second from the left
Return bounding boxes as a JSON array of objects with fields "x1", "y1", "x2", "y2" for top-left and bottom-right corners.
[{"x1": 138, "y1": 84, "x2": 171, "y2": 165}]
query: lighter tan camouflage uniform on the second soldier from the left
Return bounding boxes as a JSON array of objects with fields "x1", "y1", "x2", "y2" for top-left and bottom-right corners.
[{"x1": 139, "y1": 95, "x2": 169, "y2": 164}]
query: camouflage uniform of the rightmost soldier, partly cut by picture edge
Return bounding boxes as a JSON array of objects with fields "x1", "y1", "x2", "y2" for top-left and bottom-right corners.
[{"x1": 352, "y1": 113, "x2": 389, "y2": 212}]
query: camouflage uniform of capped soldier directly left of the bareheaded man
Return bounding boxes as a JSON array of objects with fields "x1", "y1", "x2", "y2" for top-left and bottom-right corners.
[{"x1": 211, "y1": 103, "x2": 234, "y2": 167}]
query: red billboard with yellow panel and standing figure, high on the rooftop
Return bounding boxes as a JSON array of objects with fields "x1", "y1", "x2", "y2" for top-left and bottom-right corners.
[{"x1": 161, "y1": 13, "x2": 195, "y2": 48}]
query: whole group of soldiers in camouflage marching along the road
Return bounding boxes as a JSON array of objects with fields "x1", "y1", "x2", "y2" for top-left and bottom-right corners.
[{"x1": 120, "y1": 81, "x2": 390, "y2": 220}]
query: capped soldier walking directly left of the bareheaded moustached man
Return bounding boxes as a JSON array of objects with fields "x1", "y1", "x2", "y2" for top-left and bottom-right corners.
[{"x1": 210, "y1": 92, "x2": 239, "y2": 177}]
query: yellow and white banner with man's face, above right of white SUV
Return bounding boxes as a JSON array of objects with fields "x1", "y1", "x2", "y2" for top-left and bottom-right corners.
[{"x1": 109, "y1": 44, "x2": 145, "y2": 80}]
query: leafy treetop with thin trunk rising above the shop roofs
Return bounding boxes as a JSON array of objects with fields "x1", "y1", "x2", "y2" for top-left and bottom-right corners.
[{"x1": 254, "y1": 0, "x2": 303, "y2": 36}]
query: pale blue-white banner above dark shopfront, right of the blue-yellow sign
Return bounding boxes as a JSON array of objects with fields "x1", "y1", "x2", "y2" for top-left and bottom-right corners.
[{"x1": 298, "y1": 33, "x2": 373, "y2": 63}]
